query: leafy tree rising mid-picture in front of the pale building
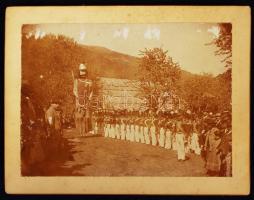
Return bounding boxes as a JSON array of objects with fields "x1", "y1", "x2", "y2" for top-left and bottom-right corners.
[{"x1": 139, "y1": 48, "x2": 181, "y2": 110}]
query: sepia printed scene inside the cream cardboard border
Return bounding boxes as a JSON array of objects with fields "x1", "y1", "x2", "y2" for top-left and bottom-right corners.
[{"x1": 6, "y1": 7, "x2": 249, "y2": 194}]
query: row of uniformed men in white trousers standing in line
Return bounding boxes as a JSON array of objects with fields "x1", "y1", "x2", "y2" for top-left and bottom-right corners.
[{"x1": 94, "y1": 116, "x2": 201, "y2": 161}]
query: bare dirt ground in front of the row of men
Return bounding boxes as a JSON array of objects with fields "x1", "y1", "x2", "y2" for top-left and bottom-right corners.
[{"x1": 39, "y1": 129, "x2": 206, "y2": 177}]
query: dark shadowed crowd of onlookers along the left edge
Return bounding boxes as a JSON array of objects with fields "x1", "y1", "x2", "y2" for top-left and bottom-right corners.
[{"x1": 21, "y1": 85, "x2": 69, "y2": 176}]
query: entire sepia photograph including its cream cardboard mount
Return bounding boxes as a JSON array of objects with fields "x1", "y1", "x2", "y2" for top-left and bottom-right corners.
[{"x1": 5, "y1": 6, "x2": 250, "y2": 194}]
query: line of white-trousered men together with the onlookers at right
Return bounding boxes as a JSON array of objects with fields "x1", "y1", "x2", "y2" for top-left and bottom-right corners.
[{"x1": 92, "y1": 110, "x2": 232, "y2": 176}]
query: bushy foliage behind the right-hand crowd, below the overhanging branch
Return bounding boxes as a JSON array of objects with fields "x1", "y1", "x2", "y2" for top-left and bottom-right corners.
[{"x1": 179, "y1": 69, "x2": 231, "y2": 112}]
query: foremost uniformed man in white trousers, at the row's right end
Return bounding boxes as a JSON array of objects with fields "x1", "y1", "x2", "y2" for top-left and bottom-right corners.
[{"x1": 175, "y1": 124, "x2": 185, "y2": 161}]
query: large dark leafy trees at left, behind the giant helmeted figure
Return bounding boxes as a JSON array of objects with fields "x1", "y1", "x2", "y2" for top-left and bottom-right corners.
[{"x1": 22, "y1": 30, "x2": 107, "y2": 114}]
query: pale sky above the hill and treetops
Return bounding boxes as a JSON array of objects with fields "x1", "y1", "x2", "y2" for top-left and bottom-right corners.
[{"x1": 27, "y1": 23, "x2": 225, "y2": 76}]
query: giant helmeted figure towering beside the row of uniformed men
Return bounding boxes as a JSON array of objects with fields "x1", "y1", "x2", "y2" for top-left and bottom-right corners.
[{"x1": 73, "y1": 63, "x2": 93, "y2": 136}]
